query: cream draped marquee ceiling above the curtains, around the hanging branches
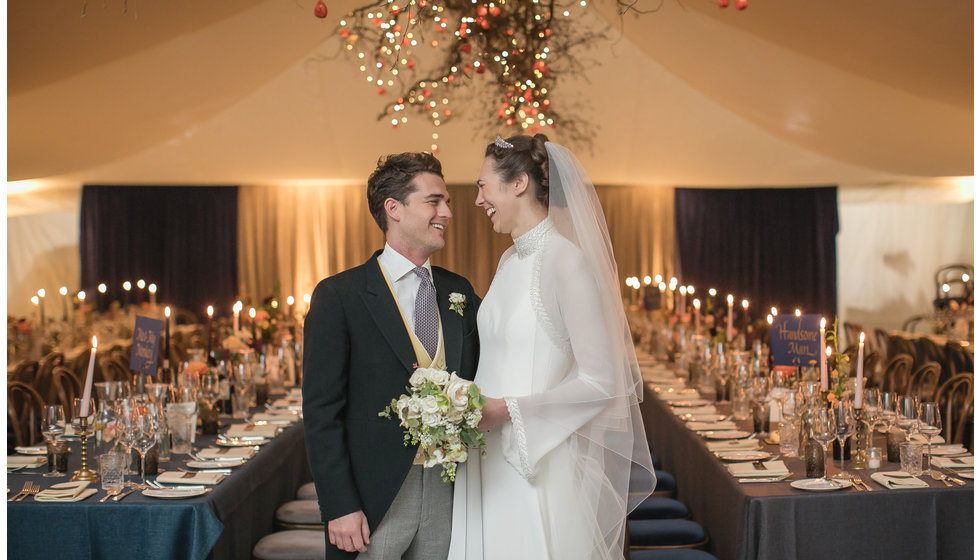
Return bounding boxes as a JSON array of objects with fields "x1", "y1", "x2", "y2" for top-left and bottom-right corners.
[{"x1": 7, "y1": 0, "x2": 973, "y2": 186}]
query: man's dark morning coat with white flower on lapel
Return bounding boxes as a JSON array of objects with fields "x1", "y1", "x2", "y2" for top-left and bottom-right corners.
[{"x1": 303, "y1": 251, "x2": 480, "y2": 559}]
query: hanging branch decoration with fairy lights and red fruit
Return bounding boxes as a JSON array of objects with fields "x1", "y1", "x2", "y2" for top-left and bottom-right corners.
[{"x1": 326, "y1": 0, "x2": 605, "y2": 152}]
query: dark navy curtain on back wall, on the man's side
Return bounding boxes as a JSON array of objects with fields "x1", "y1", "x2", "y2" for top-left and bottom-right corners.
[{"x1": 79, "y1": 185, "x2": 238, "y2": 319}]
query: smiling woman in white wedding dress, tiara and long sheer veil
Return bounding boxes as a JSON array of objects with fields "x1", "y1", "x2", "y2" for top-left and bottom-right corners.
[{"x1": 450, "y1": 134, "x2": 655, "y2": 560}]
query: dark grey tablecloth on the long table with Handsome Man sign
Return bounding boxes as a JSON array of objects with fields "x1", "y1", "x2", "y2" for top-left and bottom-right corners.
[{"x1": 642, "y1": 358, "x2": 974, "y2": 560}]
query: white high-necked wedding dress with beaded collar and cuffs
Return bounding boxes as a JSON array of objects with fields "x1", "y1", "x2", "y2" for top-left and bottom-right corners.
[{"x1": 450, "y1": 219, "x2": 652, "y2": 560}]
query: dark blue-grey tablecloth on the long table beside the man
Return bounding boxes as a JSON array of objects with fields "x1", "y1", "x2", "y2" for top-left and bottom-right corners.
[{"x1": 7, "y1": 410, "x2": 311, "y2": 560}]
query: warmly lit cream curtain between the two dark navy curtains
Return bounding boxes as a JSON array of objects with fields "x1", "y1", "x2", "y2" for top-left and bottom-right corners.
[{"x1": 238, "y1": 185, "x2": 674, "y2": 309}]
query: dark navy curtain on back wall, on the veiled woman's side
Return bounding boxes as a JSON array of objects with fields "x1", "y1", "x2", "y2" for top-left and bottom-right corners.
[{"x1": 674, "y1": 187, "x2": 839, "y2": 319}]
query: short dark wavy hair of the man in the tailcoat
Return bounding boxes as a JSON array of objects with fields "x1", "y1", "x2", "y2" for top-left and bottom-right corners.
[{"x1": 368, "y1": 152, "x2": 443, "y2": 233}]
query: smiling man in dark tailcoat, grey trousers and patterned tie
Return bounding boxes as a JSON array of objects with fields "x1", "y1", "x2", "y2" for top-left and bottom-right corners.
[{"x1": 303, "y1": 153, "x2": 480, "y2": 560}]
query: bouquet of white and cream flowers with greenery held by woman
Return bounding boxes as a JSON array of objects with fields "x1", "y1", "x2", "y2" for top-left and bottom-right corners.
[{"x1": 378, "y1": 368, "x2": 487, "y2": 482}]
